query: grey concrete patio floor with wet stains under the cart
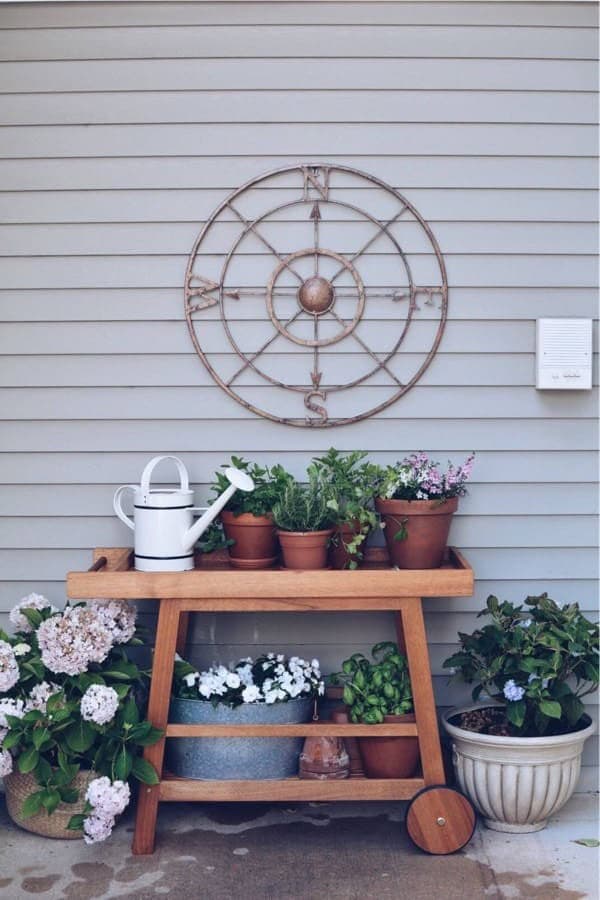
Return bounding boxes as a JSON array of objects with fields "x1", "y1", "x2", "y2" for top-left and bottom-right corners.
[{"x1": 0, "y1": 794, "x2": 598, "y2": 900}]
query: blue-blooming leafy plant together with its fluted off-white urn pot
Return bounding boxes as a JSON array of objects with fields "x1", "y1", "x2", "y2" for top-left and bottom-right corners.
[{"x1": 444, "y1": 594, "x2": 598, "y2": 832}]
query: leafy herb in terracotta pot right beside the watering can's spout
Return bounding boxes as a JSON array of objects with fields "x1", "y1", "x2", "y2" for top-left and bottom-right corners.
[{"x1": 212, "y1": 456, "x2": 292, "y2": 569}]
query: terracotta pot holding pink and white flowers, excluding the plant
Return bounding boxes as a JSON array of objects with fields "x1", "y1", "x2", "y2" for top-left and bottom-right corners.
[{"x1": 375, "y1": 497, "x2": 458, "y2": 569}]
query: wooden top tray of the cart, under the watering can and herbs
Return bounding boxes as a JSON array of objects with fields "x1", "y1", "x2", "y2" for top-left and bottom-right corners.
[{"x1": 67, "y1": 548, "x2": 473, "y2": 611}]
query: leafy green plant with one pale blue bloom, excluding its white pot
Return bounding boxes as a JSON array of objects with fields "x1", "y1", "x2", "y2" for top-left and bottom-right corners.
[{"x1": 444, "y1": 594, "x2": 598, "y2": 737}]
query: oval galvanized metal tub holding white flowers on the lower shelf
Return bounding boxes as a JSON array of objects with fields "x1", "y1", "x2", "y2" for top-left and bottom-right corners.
[{"x1": 167, "y1": 698, "x2": 313, "y2": 781}]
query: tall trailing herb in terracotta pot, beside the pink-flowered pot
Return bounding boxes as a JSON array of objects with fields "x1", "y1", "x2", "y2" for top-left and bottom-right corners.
[{"x1": 309, "y1": 447, "x2": 380, "y2": 569}]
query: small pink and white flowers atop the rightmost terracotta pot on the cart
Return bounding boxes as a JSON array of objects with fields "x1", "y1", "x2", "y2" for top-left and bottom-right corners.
[{"x1": 380, "y1": 452, "x2": 475, "y2": 502}]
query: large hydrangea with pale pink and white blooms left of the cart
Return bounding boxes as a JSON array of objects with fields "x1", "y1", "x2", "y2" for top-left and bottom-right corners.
[{"x1": 0, "y1": 594, "x2": 162, "y2": 843}]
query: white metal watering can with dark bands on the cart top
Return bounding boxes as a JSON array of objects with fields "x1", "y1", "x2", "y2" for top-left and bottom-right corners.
[{"x1": 113, "y1": 456, "x2": 254, "y2": 572}]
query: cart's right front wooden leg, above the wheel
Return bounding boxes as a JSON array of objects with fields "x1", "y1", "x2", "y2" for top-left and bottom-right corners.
[{"x1": 396, "y1": 597, "x2": 446, "y2": 785}]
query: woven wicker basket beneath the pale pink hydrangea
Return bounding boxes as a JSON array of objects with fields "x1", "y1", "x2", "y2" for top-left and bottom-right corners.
[{"x1": 4, "y1": 769, "x2": 98, "y2": 841}]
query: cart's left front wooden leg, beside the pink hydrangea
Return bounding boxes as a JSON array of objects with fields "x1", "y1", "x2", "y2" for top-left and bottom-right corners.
[{"x1": 132, "y1": 599, "x2": 180, "y2": 855}]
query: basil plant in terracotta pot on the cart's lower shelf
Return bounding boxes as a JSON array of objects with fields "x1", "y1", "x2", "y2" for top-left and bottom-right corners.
[{"x1": 330, "y1": 641, "x2": 419, "y2": 778}]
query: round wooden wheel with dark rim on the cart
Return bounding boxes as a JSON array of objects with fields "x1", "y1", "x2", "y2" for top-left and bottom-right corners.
[{"x1": 406, "y1": 784, "x2": 476, "y2": 856}]
